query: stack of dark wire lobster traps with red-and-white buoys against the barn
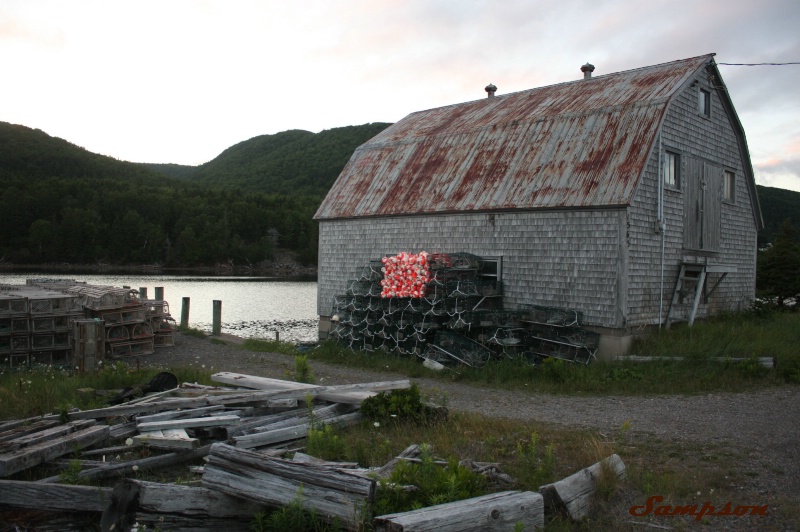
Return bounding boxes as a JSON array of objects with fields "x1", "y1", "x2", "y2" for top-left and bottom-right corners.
[{"x1": 330, "y1": 253, "x2": 599, "y2": 367}]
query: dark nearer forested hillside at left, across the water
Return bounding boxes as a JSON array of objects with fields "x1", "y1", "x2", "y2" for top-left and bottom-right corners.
[{"x1": 0, "y1": 122, "x2": 321, "y2": 266}]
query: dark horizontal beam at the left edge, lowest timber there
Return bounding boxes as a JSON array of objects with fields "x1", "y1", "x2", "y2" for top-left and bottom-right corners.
[{"x1": 0, "y1": 480, "x2": 111, "y2": 512}]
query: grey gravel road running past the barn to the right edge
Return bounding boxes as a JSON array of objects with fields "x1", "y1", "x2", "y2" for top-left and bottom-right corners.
[{"x1": 134, "y1": 334, "x2": 800, "y2": 530}]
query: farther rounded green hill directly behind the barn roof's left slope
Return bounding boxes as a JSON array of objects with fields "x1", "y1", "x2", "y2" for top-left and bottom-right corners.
[{"x1": 145, "y1": 123, "x2": 396, "y2": 195}]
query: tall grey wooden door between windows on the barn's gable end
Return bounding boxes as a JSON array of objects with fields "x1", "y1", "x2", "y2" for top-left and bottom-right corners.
[{"x1": 683, "y1": 159, "x2": 722, "y2": 251}]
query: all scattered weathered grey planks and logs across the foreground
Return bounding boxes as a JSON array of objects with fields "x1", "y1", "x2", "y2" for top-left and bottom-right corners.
[{"x1": 0, "y1": 373, "x2": 624, "y2": 532}]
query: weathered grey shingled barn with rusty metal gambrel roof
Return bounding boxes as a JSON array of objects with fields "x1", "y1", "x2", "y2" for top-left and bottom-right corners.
[{"x1": 315, "y1": 54, "x2": 763, "y2": 354}]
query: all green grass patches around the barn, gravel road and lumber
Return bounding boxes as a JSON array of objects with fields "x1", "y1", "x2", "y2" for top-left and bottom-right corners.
[{"x1": 0, "y1": 312, "x2": 800, "y2": 530}]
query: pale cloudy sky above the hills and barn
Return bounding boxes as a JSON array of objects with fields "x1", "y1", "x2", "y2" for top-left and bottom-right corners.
[{"x1": 0, "y1": 0, "x2": 800, "y2": 191}]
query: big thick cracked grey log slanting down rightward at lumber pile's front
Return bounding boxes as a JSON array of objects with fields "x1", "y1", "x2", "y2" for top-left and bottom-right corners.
[{"x1": 203, "y1": 443, "x2": 375, "y2": 529}]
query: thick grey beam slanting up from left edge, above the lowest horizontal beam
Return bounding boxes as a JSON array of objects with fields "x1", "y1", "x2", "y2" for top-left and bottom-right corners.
[{"x1": 0, "y1": 425, "x2": 109, "y2": 477}]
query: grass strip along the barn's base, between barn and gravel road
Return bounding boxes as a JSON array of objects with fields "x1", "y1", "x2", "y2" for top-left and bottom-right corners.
[{"x1": 238, "y1": 309, "x2": 800, "y2": 395}]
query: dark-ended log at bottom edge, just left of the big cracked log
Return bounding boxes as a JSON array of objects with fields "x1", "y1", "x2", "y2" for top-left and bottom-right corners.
[{"x1": 101, "y1": 480, "x2": 263, "y2": 531}]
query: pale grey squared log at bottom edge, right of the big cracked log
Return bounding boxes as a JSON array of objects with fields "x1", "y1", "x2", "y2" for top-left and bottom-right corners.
[{"x1": 374, "y1": 491, "x2": 544, "y2": 532}]
